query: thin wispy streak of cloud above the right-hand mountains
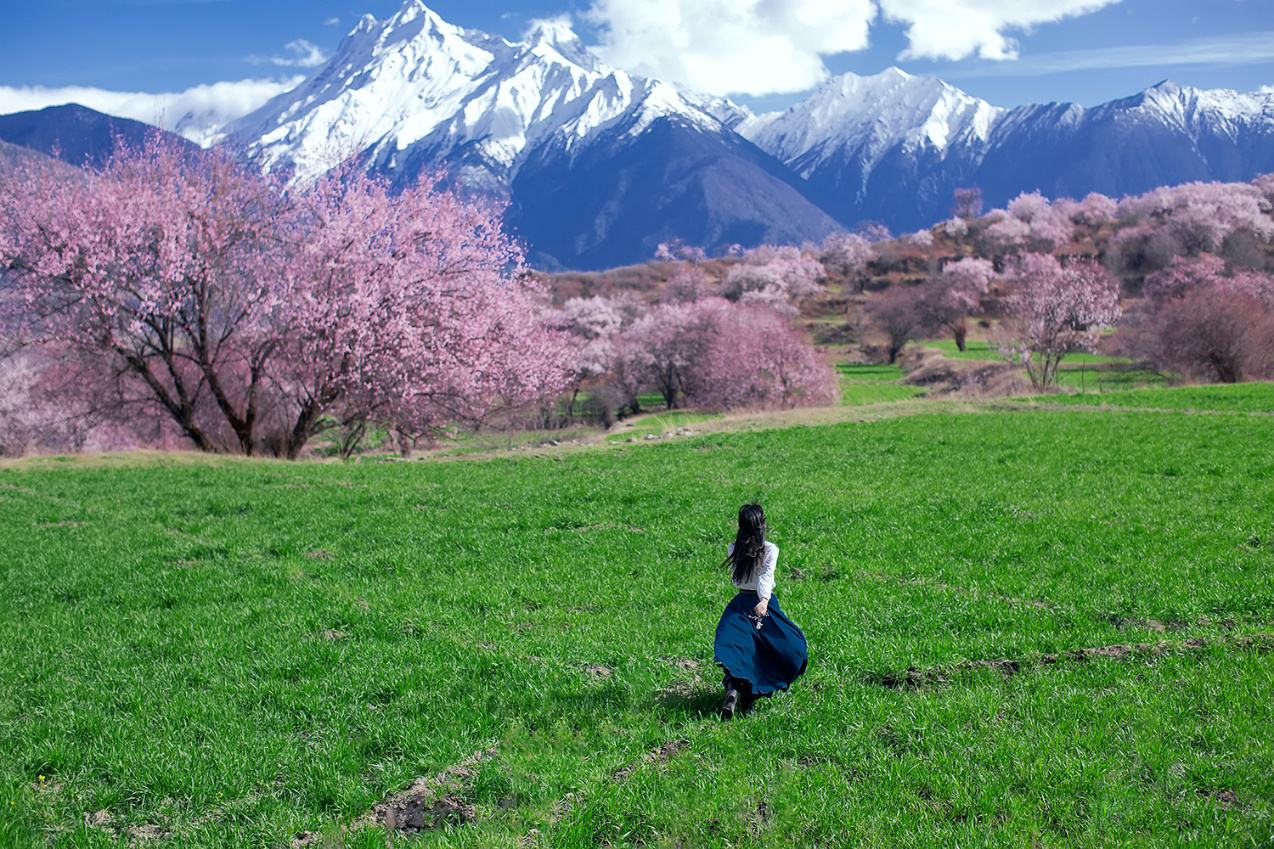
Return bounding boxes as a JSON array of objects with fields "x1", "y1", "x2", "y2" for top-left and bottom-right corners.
[{"x1": 943, "y1": 31, "x2": 1274, "y2": 78}]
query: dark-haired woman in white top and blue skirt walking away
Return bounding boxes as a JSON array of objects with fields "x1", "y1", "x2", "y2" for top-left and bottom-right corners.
[{"x1": 713, "y1": 504, "x2": 808, "y2": 719}]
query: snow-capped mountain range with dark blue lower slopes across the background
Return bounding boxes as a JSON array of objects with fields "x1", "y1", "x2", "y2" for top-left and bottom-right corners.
[{"x1": 0, "y1": 0, "x2": 1274, "y2": 269}]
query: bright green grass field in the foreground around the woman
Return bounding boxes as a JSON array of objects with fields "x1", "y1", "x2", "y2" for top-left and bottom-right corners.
[{"x1": 0, "y1": 385, "x2": 1274, "y2": 848}]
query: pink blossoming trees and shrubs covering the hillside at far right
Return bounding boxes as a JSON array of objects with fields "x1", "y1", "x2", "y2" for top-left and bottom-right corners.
[{"x1": 864, "y1": 175, "x2": 1274, "y2": 388}]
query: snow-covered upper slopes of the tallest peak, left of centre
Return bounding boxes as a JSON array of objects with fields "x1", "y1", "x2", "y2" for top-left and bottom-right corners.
[{"x1": 227, "y1": 0, "x2": 747, "y2": 185}]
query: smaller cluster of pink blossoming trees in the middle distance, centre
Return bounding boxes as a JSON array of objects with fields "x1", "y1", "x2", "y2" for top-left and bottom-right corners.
[{"x1": 555, "y1": 239, "x2": 836, "y2": 418}]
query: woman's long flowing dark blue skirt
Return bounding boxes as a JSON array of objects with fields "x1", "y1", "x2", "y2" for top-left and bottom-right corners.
[{"x1": 712, "y1": 590, "x2": 809, "y2": 696}]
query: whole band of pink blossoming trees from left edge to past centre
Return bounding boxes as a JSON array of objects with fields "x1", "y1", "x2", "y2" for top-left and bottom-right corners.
[{"x1": 0, "y1": 139, "x2": 834, "y2": 458}]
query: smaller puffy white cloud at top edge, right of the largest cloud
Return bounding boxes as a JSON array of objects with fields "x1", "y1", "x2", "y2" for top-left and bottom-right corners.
[{"x1": 880, "y1": 0, "x2": 1122, "y2": 60}]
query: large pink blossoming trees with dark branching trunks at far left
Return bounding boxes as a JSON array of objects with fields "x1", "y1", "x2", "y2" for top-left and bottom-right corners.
[{"x1": 0, "y1": 140, "x2": 571, "y2": 458}]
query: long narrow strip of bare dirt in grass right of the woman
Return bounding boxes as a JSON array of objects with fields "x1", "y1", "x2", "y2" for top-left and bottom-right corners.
[{"x1": 862, "y1": 634, "x2": 1274, "y2": 690}]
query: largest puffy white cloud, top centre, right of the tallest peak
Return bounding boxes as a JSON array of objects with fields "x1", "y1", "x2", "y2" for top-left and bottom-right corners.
[{"x1": 586, "y1": 0, "x2": 877, "y2": 94}]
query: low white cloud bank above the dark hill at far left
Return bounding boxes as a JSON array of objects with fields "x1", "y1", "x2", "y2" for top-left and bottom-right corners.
[{"x1": 0, "y1": 76, "x2": 304, "y2": 144}]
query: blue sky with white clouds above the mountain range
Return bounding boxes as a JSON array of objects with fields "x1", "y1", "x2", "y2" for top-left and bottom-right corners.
[{"x1": 0, "y1": 0, "x2": 1274, "y2": 132}]
